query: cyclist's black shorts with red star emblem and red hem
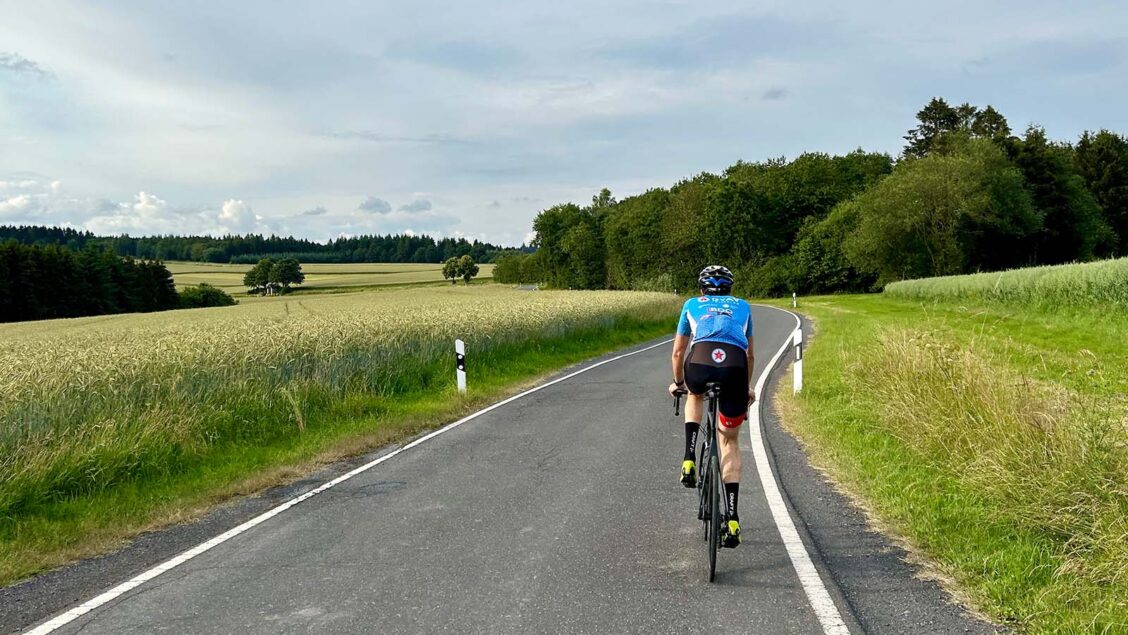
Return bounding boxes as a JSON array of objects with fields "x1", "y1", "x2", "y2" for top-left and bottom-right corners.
[{"x1": 685, "y1": 342, "x2": 748, "y2": 427}]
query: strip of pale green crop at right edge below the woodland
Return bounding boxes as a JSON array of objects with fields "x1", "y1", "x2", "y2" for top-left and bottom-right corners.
[{"x1": 884, "y1": 258, "x2": 1128, "y2": 310}]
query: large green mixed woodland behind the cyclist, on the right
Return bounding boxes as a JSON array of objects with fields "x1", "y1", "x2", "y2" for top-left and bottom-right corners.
[{"x1": 494, "y1": 98, "x2": 1128, "y2": 296}]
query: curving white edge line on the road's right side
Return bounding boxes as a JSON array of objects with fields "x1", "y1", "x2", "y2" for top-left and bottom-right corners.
[{"x1": 748, "y1": 305, "x2": 849, "y2": 635}]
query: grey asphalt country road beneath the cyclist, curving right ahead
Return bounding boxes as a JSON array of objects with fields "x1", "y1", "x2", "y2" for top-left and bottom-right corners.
[{"x1": 0, "y1": 307, "x2": 994, "y2": 634}]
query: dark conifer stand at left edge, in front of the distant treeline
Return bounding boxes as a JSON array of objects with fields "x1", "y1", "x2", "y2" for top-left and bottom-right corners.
[{"x1": 0, "y1": 240, "x2": 179, "y2": 323}]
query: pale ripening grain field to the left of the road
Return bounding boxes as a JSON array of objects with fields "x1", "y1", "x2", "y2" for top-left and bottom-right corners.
[{"x1": 0, "y1": 288, "x2": 677, "y2": 521}]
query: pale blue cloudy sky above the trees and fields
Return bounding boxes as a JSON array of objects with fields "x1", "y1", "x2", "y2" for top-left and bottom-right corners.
[{"x1": 0, "y1": 0, "x2": 1128, "y2": 245}]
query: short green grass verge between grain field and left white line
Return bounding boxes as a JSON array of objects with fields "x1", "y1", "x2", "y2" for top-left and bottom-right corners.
[{"x1": 0, "y1": 311, "x2": 671, "y2": 585}]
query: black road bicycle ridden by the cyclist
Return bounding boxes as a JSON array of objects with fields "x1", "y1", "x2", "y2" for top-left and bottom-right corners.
[{"x1": 673, "y1": 381, "x2": 729, "y2": 582}]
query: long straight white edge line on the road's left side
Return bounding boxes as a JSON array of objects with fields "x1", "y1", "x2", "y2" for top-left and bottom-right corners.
[{"x1": 25, "y1": 338, "x2": 673, "y2": 635}]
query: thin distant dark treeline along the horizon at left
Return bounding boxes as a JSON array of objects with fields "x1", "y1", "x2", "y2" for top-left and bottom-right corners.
[{"x1": 0, "y1": 226, "x2": 513, "y2": 264}]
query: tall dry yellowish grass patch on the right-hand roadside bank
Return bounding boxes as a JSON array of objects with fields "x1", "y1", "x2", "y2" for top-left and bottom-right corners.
[{"x1": 855, "y1": 329, "x2": 1128, "y2": 633}]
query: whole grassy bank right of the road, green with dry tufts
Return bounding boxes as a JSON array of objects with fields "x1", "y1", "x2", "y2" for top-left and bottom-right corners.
[{"x1": 779, "y1": 296, "x2": 1128, "y2": 634}]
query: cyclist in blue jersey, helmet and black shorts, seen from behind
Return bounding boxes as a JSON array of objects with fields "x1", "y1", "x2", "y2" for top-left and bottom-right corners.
[{"x1": 670, "y1": 265, "x2": 756, "y2": 548}]
